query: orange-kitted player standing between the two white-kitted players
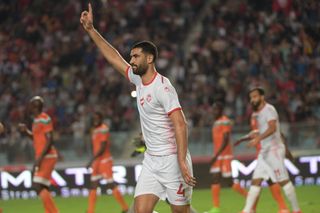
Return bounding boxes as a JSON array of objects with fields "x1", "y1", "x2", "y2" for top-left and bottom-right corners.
[{"x1": 208, "y1": 102, "x2": 247, "y2": 213}]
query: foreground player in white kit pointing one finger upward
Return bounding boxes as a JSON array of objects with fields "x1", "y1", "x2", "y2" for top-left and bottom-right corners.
[{"x1": 80, "y1": 4, "x2": 196, "y2": 213}]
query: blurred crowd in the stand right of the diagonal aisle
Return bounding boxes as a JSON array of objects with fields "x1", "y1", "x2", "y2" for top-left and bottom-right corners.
[{"x1": 176, "y1": 0, "x2": 320, "y2": 127}]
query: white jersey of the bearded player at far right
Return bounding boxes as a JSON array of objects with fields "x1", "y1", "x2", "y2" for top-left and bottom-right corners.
[{"x1": 252, "y1": 103, "x2": 284, "y2": 152}]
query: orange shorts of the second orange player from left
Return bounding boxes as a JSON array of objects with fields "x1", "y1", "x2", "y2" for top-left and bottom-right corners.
[{"x1": 91, "y1": 158, "x2": 113, "y2": 182}]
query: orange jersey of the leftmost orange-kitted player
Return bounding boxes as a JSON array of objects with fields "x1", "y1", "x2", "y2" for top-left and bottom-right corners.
[{"x1": 32, "y1": 112, "x2": 57, "y2": 158}]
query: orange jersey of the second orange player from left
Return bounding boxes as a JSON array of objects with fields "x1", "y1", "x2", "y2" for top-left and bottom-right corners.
[{"x1": 92, "y1": 124, "x2": 111, "y2": 159}]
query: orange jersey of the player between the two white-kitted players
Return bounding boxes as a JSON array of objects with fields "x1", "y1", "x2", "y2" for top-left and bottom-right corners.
[{"x1": 212, "y1": 115, "x2": 232, "y2": 157}]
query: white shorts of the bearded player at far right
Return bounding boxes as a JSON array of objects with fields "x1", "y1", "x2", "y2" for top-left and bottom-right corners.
[{"x1": 252, "y1": 146, "x2": 289, "y2": 183}]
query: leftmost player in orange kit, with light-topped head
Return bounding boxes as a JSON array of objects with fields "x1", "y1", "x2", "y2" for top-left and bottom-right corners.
[{"x1": 19, "y1": 96, "x2": 58, "y2": 213}]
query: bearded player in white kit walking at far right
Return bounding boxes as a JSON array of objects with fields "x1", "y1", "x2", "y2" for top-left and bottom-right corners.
[{"x1": 242, "y1": 87, "x2": 301, "y2": 213}]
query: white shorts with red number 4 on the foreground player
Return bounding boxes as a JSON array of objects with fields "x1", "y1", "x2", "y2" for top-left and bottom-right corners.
[{"x1": 134, "y1": 153, "x2": 193, "y2": 205}]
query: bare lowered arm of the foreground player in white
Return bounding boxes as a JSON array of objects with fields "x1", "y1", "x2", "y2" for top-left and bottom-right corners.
[{"x1": 170, "y1": 110, "x2": 196, "y2": 186}]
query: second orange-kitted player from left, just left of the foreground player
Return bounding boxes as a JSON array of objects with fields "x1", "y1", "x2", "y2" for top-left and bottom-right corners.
[{"x1": 87, "y1": 112, "x2": 128, "y2": 213}]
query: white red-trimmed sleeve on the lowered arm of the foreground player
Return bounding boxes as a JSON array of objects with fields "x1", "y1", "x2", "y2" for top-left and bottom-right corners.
[{"x1": 156, "y1": 78, "x2": 181, "y2": 115}]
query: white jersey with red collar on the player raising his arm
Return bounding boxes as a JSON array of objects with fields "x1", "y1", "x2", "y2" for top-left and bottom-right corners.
[{"x1": 127, "y1": 66, "x2": 181, "y2": 156}]
